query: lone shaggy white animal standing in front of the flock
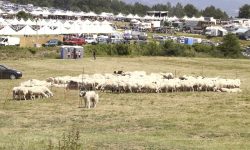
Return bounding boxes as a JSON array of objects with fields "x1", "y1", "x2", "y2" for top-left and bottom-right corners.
[{"x1": 80, "y1": 91, "x2": 99, "y2": 109}]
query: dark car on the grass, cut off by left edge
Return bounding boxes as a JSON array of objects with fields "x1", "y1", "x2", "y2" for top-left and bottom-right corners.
[{"x1": 0, "y1": 65, "x2": 22, "y2": 80}]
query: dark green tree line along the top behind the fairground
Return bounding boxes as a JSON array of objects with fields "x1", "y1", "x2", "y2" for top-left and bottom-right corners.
[{"x1": 7, "y1": 0, "x2": 250, "y2": 19}]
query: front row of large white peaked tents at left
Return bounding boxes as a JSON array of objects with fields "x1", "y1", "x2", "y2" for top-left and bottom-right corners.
[{"x1": 0, "y1": 19, "x2": 116, "y2": 35}]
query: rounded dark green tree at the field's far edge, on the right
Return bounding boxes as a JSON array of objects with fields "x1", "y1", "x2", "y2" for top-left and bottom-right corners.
[{"x1": 218, "y1": 34, "x2": 241, "y2": 58}]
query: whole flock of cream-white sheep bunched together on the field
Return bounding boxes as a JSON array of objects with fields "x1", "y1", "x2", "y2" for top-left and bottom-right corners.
[{"x1": 13, "y1": 71, "x2": 241, "y2": 99}]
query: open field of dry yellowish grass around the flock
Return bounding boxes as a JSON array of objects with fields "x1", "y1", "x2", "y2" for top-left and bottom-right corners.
[{"x1": 0, "y1": 57, "x2": 250, "y2": 150}]
